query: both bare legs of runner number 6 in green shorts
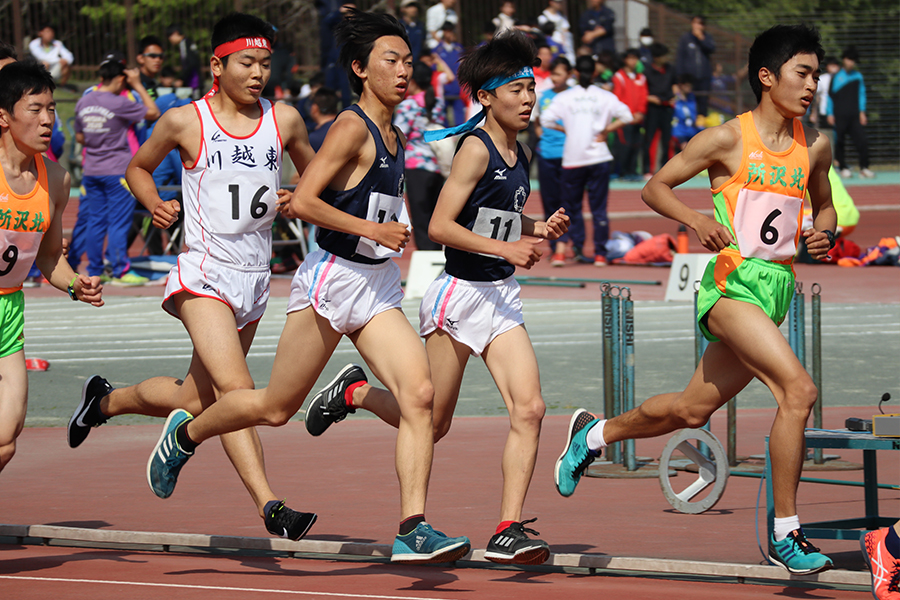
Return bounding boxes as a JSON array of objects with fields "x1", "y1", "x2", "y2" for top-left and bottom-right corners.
[{"x1": 603, "y1": 298, "x2": 817, "y2": 518}]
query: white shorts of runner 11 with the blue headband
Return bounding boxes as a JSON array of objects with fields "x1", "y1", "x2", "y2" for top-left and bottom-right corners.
[{"x1": 419, "y1": 271, "x2": 525, "y2": 356}]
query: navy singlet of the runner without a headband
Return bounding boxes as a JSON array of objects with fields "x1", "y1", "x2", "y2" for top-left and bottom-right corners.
[{"x1": 316, "y1": 104, "x2": 405, "y2": 264}]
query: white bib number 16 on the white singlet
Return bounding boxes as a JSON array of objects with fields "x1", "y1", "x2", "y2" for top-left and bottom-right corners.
[{"x1": 207, "y1": 172, "x2": 278, "y2": 233}]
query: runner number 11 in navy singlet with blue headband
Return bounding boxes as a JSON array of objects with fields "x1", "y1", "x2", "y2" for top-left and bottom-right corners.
[{"x1": 307, "y1": 31, "x2": 569, "y2": 564}]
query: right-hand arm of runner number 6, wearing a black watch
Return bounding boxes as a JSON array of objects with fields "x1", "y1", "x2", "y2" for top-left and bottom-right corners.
[{"x1": 803, "y1": 127, "x2": 837, "y2": 260}]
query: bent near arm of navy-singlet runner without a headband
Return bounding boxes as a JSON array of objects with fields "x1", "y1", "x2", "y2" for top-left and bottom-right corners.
[{"x1": 284, "y1": 113, "x2": 409, "y2": 252}]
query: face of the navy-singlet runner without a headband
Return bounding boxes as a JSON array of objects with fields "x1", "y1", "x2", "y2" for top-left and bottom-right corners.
[{"x1": 353, "y1": 35, "x2": 412, "y2": 107}]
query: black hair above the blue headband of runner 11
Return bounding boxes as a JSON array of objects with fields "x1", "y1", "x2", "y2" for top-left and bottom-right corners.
[{"x1": 457, "y1": 29, "x2": 540, "y2": 102}]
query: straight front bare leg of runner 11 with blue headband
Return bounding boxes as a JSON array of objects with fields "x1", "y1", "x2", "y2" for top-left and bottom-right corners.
[{"x1": 482, "y1": 326, "x2": 545, "y2": 522}]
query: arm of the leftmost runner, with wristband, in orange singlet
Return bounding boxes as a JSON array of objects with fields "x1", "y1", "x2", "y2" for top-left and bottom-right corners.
[{"x1": 35, "y1": 160, "x2": 103, "y2": 306}]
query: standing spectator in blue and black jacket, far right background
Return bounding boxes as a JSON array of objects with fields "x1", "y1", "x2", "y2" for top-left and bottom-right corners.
[{"x1": 828, "y1": 46, "x2": 875, "y2": 179}]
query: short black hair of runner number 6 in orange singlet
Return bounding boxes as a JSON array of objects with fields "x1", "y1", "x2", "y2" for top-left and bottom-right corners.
[{"x1": 747, "y1": 23, "x2": 825, "y2": 102}]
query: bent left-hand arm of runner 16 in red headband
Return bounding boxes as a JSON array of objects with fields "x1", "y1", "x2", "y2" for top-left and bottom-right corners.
[{"x1": 125, "y1": 105, "x2": 200, "y2": 229}]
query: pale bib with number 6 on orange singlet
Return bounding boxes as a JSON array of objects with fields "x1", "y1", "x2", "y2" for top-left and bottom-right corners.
[{"x1": 734, "y1": 189, "x2": 803, "y2": 260}]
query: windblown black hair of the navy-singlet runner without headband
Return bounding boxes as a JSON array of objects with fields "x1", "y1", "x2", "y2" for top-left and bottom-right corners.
[{"x1": 334, "y1": 8, "x2": 412, "y2": 94}]
